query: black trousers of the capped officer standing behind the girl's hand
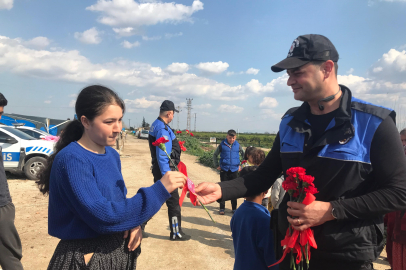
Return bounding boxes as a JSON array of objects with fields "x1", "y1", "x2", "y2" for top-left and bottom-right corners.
[{"x1": 142, "y1": 166, "x2": 182, "y2": 232}]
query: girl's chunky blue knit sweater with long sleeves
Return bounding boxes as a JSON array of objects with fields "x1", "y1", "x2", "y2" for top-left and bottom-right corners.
[{"x1": 48, "y1": 142, "x2": 171, "y2": 239}]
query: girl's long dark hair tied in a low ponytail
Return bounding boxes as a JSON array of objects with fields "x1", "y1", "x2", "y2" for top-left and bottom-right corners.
[{"x1": 36, "y1": 85, "x2": 125, "y2": 195}]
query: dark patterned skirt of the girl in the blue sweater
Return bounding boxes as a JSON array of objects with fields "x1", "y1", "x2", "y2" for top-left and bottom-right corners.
[{"x1": 48, "y1": 233, "x2": 141, "y2": 270}]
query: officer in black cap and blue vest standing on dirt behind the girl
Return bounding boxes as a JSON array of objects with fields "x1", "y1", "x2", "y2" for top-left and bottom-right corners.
[{"x1": 144, "y1": 100, "x2": 190, "y2": 241}]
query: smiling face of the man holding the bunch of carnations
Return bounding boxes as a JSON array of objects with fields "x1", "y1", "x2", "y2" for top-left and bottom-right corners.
[{"x1": 287, "y1": 63, "x2": 323, "y2": 102}]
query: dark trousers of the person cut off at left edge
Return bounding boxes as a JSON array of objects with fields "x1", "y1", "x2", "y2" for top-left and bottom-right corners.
[{"x1": 0, "y1": 203, "x2": 23, "y2": 270}]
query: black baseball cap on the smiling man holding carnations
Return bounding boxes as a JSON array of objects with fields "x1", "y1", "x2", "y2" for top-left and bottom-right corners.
[{"x1": 271, "y1": 34, "x2": 338, "y2": 72}]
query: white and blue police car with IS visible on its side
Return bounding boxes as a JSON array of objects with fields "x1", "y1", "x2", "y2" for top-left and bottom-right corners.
[{"x1": 0, "y1": 126, "x2": 55, "y2": 180}]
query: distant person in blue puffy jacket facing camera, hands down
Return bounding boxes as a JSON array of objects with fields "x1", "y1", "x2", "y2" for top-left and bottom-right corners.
[{"x1": 213, "y1": 129, "x2": 244, "y2": 215}]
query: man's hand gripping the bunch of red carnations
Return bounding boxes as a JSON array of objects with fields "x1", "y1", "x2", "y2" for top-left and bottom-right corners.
[{"x1": 288, "y1": 201, "x2": 334, "y2": 231}]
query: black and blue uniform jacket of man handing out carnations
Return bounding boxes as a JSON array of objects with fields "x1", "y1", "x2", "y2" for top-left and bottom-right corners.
[{"x1": 220, "y1": 85, "x2": 406, "y2": 264}]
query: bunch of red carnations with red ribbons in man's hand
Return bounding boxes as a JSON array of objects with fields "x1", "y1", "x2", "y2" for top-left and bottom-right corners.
[{"x1": 269, "y1": 167, "x2": 318, "y2": 270}]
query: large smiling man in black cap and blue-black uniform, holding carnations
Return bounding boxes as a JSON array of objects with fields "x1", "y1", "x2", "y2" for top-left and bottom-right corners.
[{"x1": 195, "y1": 35, "x2": 406, "y2": 270}]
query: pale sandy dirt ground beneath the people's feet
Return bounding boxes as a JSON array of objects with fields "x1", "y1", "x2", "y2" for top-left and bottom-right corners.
[{"x1": 3, "y1": 136, "x2": 389, "y2": 270}]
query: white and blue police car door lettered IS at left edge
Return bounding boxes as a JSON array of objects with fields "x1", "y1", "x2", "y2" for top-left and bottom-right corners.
[{"x1": 0, "y1": 130, "x2": 20, "y2": 168}]
